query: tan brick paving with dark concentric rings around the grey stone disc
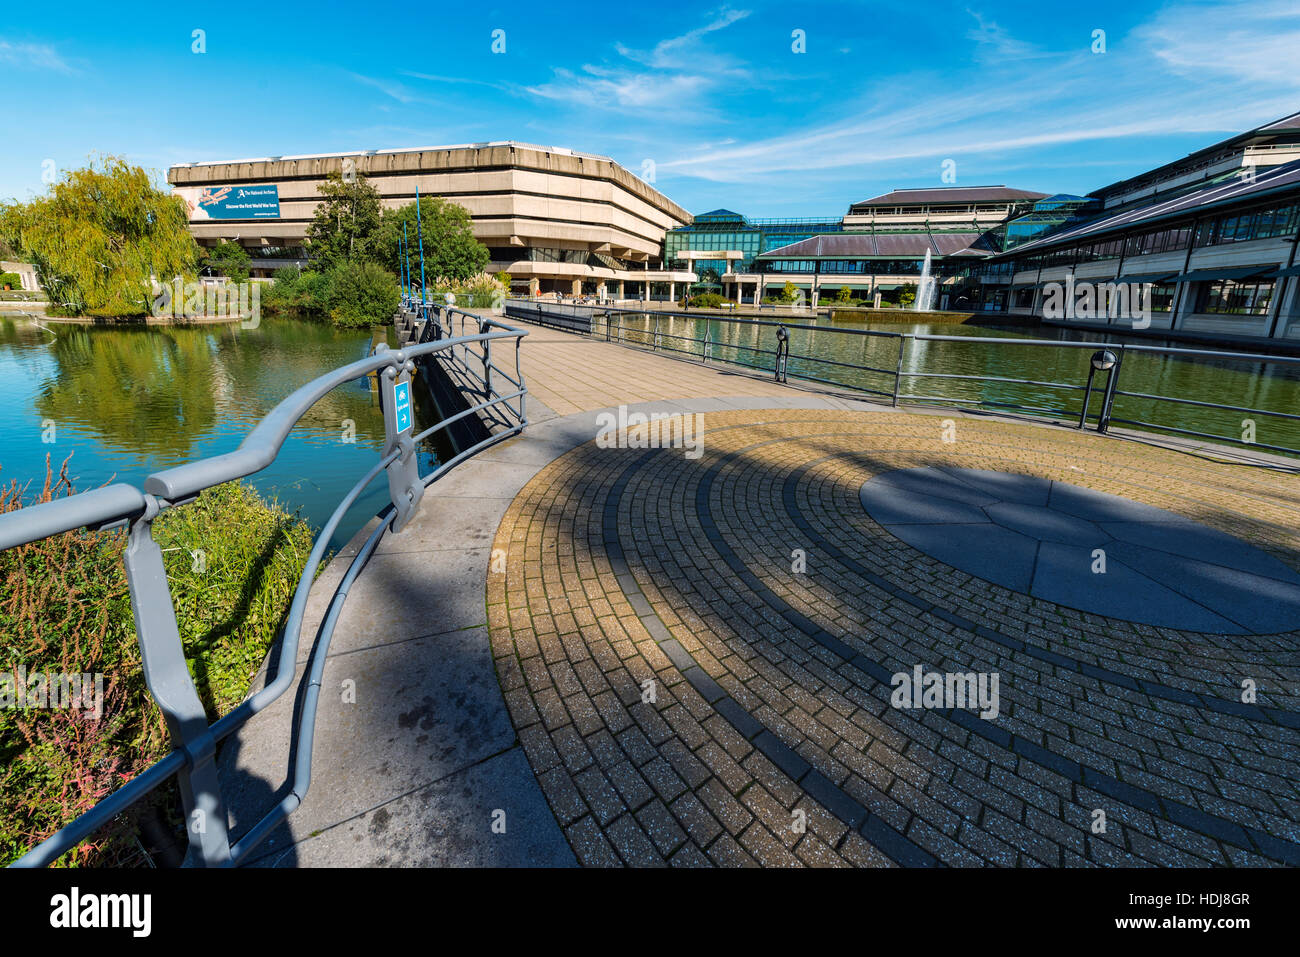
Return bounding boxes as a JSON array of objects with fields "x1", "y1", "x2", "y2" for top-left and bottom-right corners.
[{"x1": 488, "y1": 410, "x2": 1300, "y2": 866}]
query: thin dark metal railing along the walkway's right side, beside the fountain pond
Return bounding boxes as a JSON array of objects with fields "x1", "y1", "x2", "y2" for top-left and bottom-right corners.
[{"x1": 507, "y1": 300, "x2": 1300, "y2": 455}]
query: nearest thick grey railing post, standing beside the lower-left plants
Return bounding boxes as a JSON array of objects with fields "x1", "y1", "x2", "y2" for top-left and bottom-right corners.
[{"x1": 124, "y1": 504, "x2": 230, "y2": 867}]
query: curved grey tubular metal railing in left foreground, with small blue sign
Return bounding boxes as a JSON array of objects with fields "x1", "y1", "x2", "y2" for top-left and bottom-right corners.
[{"x1": 0, "y1": 300, "x2": 528, "y2": 867}]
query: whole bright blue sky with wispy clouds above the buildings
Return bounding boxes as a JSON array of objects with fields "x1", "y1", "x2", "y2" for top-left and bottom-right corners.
[{"x1": 0, "y1": 0, "x2": 1300, "y2": 216}]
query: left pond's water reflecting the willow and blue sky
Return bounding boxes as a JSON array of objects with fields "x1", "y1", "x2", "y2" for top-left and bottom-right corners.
[{"x1": 0, "y1": 320, "x2": 433, "y2": 545}]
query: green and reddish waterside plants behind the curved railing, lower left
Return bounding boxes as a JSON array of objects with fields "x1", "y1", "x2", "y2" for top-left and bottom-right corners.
[{"x1": 0, "y1": 462, "x2": 312, "y2": 866}]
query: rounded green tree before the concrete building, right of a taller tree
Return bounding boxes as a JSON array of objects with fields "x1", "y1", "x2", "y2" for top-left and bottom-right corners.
[{"x1": 374, "y1": 196, "x2": 493, "y2": 289}]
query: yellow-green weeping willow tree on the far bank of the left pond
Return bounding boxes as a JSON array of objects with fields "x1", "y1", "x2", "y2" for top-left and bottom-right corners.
[{"x1": 0, "y1": 156, "x2": 199, "y2": 316}]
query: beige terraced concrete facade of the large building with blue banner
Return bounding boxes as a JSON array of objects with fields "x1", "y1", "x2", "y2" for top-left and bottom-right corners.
[{"x1": 168, "y1": 142, "x2": 690, "y2": 295}]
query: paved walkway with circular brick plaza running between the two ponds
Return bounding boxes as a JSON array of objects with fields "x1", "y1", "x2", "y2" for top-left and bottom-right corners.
[{"x1": 221, "y1": 321, "x2": 1300, "y2": 866}]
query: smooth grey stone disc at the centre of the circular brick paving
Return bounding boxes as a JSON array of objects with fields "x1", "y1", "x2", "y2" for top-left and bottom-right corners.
[{"x1": 861, "y1": 465, "x2": 1300, "y2": 635}]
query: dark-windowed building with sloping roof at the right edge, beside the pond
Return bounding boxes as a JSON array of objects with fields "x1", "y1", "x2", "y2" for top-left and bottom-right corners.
[{"x1": 972, "y1": 113, "x2": 1300, "y2": 342}]
